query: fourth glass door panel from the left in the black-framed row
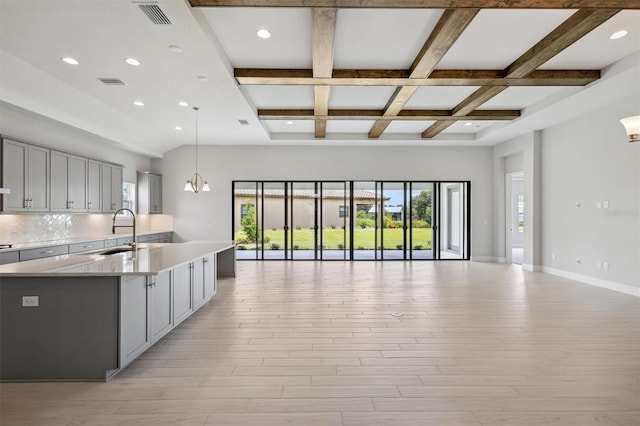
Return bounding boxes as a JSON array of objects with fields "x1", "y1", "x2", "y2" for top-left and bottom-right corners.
[{"x1": 320, "y1": 182, "x2": 350, "y2": 260}]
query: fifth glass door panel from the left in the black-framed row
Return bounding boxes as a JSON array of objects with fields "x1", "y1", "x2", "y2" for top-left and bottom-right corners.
[{"x1": 352, "y1": 182, "x2": 380, "y2": 260}]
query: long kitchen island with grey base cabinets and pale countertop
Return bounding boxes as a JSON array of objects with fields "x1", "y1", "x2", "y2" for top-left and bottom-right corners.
[{"x1": 0, "y1": 241, "x2": 235, "y2": 381}]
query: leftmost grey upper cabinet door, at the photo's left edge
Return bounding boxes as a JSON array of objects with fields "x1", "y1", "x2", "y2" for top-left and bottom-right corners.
[{"x1": 2, "y1": 139, "x2": 29, "y2": 212}]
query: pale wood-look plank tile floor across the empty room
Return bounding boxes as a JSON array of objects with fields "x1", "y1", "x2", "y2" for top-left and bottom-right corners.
[{"x1": 0, "y1": 262, "x2": 640, "y2": 426}]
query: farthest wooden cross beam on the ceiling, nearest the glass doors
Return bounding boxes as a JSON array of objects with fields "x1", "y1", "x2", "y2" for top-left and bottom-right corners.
[{"x1": 258, "y1": 109, "x2": 520, "y2": 121}]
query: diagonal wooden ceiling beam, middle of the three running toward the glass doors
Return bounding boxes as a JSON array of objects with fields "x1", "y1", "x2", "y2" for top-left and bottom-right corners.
[{"x1": 369, "y1": 9, "x2": 479, "y2": 138}]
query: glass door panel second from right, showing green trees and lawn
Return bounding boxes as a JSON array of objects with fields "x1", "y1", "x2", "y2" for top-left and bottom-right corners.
[{"x1": 407, "y1": 182, "x2": 434, "y2": 259}]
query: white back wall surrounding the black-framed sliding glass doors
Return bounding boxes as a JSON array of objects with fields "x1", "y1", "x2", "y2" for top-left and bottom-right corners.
[{"x1": 162, "y1": 146, "x2": 493, "y2": 260}]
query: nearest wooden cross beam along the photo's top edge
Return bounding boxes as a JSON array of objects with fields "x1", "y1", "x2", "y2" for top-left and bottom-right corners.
[{"x1": 189, "y1": 0, "x2": 640, "y2": 9}]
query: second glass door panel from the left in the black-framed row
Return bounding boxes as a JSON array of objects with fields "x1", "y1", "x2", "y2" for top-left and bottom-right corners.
[{"x1": 258, "y1": 182, "x2": 288, "y2": 259}]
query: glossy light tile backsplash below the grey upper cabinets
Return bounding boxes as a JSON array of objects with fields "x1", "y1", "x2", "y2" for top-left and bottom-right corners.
[{"x1": 0, "y1": 213, "x2": 173, "y2": 244}]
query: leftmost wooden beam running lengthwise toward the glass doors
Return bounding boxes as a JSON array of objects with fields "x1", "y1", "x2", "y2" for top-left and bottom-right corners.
[{"x1": 313, "y1": 8, "x2": 337, "y2": 138}]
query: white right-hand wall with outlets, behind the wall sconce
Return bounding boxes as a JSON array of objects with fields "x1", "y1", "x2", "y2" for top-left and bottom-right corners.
[{"x1": 541, "y1": 97, "x2": 640, "y2": 295}]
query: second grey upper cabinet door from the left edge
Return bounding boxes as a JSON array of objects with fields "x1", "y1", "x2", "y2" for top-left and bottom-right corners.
[{"x1": 27, "y1": 145, "x2": 50, "y2": 212}]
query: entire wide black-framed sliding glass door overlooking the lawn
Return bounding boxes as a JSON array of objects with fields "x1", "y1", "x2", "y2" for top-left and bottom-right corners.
[{"x1": 233, "y1": 181, "x2": 471, "y2": 260}]
